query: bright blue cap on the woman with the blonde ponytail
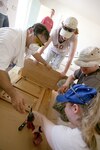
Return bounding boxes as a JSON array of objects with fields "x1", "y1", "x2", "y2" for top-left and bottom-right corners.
[{"x1": 56, "y1": 84, "x2": 97, "y2": 105}]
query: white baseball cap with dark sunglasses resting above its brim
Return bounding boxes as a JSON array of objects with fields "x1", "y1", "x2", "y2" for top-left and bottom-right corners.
[{"x1": 60, "y1": 17, "x2": 78, "y2": 39}]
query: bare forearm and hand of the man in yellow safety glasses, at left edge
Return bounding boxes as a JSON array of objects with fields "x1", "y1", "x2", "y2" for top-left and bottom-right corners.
[{"x1": 0, "y1": 70, "x2": 25, "y2": 113}]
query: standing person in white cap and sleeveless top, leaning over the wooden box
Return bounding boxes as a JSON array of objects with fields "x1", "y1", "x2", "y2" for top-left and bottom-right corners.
[{"x1": 40, "y1": 17, "x2": 78, "y2": 76}]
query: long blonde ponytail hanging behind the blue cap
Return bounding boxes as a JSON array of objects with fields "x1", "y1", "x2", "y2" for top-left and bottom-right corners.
[{"x1": 82, "y1": 93, "x2": 100, "y2": 150}]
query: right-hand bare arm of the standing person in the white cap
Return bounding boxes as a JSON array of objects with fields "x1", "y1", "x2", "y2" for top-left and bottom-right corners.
[{"x1": 61, "y1": 37, "x2": 77, "y2": 76}]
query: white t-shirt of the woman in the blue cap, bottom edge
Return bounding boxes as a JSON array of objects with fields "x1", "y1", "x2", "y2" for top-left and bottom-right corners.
[{"x1": 51, "y1": 125, "x2": 90, "y2": 150}]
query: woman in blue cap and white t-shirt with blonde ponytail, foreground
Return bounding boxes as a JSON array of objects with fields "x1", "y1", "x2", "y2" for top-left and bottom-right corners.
[{"x1": 33, "y1": 84, "x2": 100, "y2": 150}]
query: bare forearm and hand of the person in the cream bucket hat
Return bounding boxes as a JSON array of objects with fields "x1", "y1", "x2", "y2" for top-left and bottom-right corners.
[{"x1": 58, "y1": 74, "x2": 75, "y2": 93}]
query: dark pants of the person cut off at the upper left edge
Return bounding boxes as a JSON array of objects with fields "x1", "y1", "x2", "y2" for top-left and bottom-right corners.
[{"x1": 0, "y1": 13, "x2": 9, "y2": 28}]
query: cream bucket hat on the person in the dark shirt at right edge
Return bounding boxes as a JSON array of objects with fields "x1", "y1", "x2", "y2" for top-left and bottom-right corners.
[{"x1": 74, "y1": 47, "x2": 100, "y2": 67}]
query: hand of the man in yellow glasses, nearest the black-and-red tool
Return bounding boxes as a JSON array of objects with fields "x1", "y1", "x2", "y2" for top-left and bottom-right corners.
[{"x1": 11, "y1": 92, "x2": 25, "y2": 113}]
